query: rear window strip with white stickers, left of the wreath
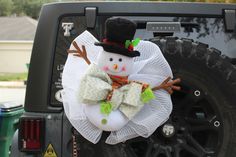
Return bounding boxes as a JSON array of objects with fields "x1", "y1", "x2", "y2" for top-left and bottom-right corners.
[{"x1": 51, "y1": 16, "x2": 86, "y2": 106}]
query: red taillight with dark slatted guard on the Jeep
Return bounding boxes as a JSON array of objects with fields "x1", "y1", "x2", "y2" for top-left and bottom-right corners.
[{"x1": 18, "y1": 117, "x2": 45, "y2": 152}]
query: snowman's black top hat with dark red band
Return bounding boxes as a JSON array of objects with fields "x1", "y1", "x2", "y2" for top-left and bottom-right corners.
[{"x1": 95, "y1": 17, "x2": 140, "y2": 57}]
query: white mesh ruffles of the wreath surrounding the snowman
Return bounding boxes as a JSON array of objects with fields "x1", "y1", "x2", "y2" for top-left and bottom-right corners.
[{"x1": 62, "y1": 31, "x2": 173, "y2": 144}]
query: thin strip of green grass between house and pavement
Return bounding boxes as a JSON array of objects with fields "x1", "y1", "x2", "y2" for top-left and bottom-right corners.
[{"x1": 0, "y1": 73, "x2": 28, "y2": 81}]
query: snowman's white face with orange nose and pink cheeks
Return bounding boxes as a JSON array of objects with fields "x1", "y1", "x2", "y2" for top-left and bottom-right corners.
[{"x1": 97, "y1": 51, "x2": 134, "y2": 76}]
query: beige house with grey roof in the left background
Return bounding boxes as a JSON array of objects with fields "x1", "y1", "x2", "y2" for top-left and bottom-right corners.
[{"x1": 0, "y1": 16, "x2": 37, "y2": 73}]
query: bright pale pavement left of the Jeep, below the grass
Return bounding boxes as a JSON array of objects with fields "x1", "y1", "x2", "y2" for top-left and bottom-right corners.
[{"x1": 0, "y1": 88, "x2": 25, "y2": 104}]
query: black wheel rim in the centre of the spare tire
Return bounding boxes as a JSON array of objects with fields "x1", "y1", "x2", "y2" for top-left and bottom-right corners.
[{"x1": 123, "y1": 81, "x2": 224, "y2": 157}]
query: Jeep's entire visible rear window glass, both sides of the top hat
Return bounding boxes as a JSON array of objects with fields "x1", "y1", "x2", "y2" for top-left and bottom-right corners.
[{"x1": 50, "y1": 16, "x2": 236, "y2": 106}]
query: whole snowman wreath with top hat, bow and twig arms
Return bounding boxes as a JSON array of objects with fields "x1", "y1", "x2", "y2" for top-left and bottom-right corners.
[{"x1": 62, "y1": 17, "x2": 180, "y2": 144}]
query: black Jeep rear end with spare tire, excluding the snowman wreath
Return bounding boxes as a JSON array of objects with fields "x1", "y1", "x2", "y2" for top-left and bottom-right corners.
[{"x1": 11, "y1": 2, "x2": 236, "y2": 157}]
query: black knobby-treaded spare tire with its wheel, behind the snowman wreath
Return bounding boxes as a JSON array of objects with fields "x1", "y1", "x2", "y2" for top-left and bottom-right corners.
[{"x1": 136, "y1": 37, "x2": 236, "y2": 157}]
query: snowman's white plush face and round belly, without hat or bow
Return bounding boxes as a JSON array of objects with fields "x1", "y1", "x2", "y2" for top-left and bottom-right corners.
[{"x1": 84, "y1": 51, "x2": 134, "y2": 131}]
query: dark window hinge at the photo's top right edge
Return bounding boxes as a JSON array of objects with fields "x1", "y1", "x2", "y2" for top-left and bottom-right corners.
[{"x1": 224, "y1": 9, "x2": 236, "y2": 31}]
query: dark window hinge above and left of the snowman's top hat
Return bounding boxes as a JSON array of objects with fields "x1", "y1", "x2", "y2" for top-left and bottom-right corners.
[{"x1": 85, "y1": 7, "x2": 97, "y2": 28}]
